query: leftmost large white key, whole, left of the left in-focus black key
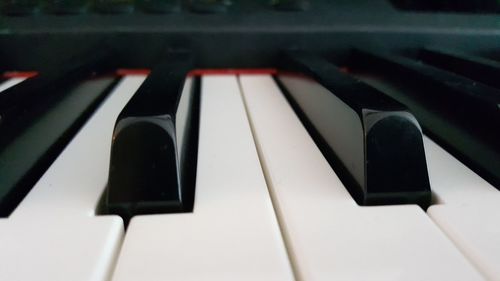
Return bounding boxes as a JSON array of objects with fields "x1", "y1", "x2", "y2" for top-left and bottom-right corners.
[{"x1": 0, "y1": 76, "x2": 145, "y2": 281}]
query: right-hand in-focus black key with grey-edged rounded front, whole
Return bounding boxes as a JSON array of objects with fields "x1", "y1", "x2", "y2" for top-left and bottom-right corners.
[{"x1": 278, "y1": 53, "x2": 431, "y2": 208}]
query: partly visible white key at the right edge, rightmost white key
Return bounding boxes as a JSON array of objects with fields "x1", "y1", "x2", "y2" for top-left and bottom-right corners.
[{"x1": 424, "y1": 138, "x2": 500, "y2": 280}]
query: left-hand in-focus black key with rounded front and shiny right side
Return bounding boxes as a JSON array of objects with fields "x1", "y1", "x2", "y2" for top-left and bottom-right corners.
[{"x1": 102, "y1": 54, "x2": 199, "y2": 223}]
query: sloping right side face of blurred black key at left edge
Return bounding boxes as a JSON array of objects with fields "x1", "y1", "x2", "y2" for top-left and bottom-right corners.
[{"x1": 0, "y1": 73, "x2": 115, "y2": 216}]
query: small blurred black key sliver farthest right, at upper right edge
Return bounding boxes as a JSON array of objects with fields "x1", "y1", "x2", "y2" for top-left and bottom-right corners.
[{"x1": 419, "y1": 48, "x2": 500, "y2": 88}]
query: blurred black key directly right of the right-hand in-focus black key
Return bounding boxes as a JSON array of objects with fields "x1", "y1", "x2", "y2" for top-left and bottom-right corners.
[{"x1": 353, "y1": 47, "x2": 500, "y2": 188}]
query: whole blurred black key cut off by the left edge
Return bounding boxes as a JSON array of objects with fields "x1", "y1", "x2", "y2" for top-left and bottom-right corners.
[{"x1": 0, "y1": 64, "x2": 115, "y2": 217}]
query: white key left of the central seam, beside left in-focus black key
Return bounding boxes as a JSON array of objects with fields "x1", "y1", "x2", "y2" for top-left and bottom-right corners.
[{"x1": 112, "y1": 75, "x2": 294, "y2": 281}]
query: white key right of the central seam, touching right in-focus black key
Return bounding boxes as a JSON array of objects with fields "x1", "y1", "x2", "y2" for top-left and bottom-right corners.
[{"x1": 240, "y1": 75, "x2": 483, "y2": 280}]
